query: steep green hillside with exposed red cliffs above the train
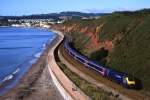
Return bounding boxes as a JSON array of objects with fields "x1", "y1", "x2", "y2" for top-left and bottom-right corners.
[{"x1": 53, "y1": 9, "x2": 150, "y2": 92}]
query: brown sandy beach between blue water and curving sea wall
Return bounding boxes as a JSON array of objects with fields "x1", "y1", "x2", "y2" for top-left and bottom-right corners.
[{"x1": 0, "y1": 31, "x2": 63, "y2": 100}]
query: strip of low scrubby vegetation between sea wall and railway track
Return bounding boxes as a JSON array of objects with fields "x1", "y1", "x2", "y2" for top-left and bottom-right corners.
[{"x1": 58, "y1": 63, "x2": 119, "y2": 100}]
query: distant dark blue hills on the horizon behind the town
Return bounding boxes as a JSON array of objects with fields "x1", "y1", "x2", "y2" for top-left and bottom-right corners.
[{"x1": 0, "y1": 11, "x2": 107, "y2": 20}]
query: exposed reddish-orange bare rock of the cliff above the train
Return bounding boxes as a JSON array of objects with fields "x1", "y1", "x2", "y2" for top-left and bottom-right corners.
[{"x1": 53, "y1": 23, "x2": 114, "y2": 51}]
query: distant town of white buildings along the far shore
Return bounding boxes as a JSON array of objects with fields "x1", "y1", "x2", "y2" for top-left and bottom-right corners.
[{"x1": 0, "y1": 18, "x2": 68, "y2": 28}]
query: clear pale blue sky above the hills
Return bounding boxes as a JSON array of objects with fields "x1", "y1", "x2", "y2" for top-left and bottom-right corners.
[{"x1": 0, "y1": 0, "x2": 150, "y2": 16}]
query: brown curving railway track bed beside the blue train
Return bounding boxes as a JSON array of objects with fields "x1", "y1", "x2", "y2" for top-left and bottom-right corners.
[{"x1": 59, "y1": 45, "x2": 150, "y2": 100}]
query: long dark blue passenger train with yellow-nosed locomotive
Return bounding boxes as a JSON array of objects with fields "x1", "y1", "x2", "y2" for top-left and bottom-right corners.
[{"x1": 63, "y1": 39, "x2": 136, "y2": 88}]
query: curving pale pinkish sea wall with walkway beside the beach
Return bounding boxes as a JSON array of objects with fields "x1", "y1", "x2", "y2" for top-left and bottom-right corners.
[{"x1": 47, "y1": 31, "x2": 89, "y2": 100}]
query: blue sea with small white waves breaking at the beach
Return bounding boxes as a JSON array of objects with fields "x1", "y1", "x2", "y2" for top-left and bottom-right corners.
[{"x1": 0, "y1": 27, "x2": 56, "y2": 96}]
